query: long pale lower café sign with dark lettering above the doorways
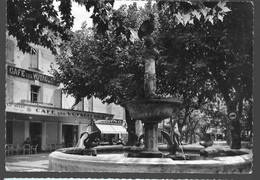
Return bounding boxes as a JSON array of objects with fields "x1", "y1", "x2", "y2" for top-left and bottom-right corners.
[{"x1": 6, "y1": 103, "x2": 113, "y2": 119}]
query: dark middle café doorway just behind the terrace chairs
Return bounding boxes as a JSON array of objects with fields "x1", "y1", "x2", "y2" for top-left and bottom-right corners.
[{"x1": 30, "y1": 122, "x2": 42, "y2": 151}]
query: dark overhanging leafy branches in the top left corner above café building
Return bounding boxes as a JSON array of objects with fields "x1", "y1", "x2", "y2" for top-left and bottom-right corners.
[{"x1": 7, "y1": 0, "x2": 114, "y2": 54}]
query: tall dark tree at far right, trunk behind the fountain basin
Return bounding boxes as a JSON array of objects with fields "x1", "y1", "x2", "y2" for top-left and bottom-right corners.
[{"x1": 197, "y1": 2, "x2": 253, "y2": 149}]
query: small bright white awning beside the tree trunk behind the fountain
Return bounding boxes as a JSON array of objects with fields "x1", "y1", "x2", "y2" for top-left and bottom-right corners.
[{"x1": 96, "y1": 124, "x2": 127, "y2": 134}]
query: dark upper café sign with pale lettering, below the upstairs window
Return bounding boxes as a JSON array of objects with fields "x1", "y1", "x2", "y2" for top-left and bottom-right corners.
[{"x1": 7, "y1": 66, "x2": 58, "y2": 86}]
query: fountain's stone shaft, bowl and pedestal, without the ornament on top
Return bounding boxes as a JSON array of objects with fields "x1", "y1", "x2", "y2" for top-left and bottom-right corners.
[{"x1": 122, "y1": 58, "x2": 181, "y2": 157}]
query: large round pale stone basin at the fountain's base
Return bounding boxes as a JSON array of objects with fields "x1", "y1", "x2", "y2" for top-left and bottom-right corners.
[{"x1": 49, "y1": 144, "x2": 252, "y2": 174}]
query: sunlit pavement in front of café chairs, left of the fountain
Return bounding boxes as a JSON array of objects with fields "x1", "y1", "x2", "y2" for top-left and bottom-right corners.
[{"x1": 5, "y1": 153, "x2": 49, "y2": 172}]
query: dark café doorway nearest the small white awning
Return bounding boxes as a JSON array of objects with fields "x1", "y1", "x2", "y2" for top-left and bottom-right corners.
[{"x1": 62, "y1": 124, "x2": 78, "y2": 147}]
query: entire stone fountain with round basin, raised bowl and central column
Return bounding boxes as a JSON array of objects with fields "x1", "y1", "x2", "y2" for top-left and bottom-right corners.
[{"x1": 49, "y1": 13, "x2": 252, "y2": 173}]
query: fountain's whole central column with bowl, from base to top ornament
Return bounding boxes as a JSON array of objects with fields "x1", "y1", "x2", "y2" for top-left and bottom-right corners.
[{"x1": 122, "y1": 14, "x2": 181, "y2": 157}]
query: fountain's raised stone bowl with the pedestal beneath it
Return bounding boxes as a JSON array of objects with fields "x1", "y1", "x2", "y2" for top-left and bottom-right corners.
[{"x1": 122, "y1": 98, "x2": 181, "y2": 157}]
